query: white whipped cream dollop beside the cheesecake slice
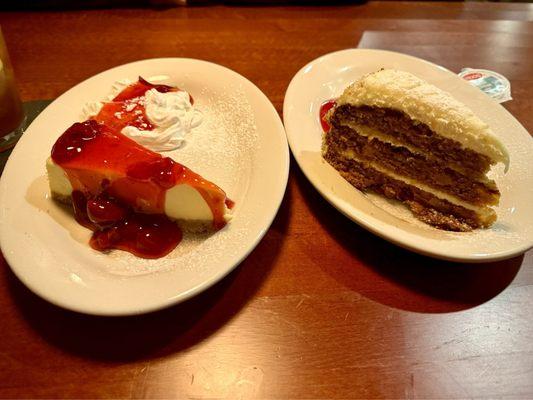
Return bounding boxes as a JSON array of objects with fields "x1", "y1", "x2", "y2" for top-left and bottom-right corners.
[{"x1": 122, "y1": 89, "x2": 203, "y2": 151}]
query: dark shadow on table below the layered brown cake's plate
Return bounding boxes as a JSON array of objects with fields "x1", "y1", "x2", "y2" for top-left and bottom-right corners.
[{"x1": 293, "y1": 162, "x2": 524, "y2": 313}]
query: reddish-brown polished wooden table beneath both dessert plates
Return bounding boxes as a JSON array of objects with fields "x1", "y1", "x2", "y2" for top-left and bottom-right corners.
[{"x1": 0, "y1": 2, "x2": 533, "y2": 399}]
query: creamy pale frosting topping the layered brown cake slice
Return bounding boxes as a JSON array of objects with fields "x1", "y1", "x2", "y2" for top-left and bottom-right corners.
[{"x1": 337, "y1": 69, "x2": 509, "y2": 169}]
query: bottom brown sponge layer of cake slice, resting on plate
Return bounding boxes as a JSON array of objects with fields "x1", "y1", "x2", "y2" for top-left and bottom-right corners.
[{"x1": 324, "y1": 149, "x2": 496, "y2": 232}]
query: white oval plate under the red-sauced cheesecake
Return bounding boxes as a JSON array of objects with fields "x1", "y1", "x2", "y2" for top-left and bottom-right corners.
[{"x1": 0, "y1": 58, "x2": 289, "y2": 315}]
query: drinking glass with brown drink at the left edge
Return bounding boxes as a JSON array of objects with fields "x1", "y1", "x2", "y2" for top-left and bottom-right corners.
[{"x1": 0, "y1": 28, "x2": 25, "y2": 152}]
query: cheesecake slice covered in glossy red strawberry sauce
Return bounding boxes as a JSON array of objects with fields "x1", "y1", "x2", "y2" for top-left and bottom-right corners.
[{"x1": 46, "y1": 118, "x2": 233, "y2": 258}]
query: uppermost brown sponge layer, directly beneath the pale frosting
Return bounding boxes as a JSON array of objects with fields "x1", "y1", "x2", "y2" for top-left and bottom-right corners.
[{"x1": 330, "y1": 105, "x2": 491, "y2": 179}]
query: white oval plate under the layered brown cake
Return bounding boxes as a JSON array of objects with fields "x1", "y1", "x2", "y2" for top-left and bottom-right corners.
[{"x1": 283, "y1": 49, "x2": 533, "y2": 262}]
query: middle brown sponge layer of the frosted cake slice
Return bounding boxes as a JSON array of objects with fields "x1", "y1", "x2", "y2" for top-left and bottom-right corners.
[{"x1": 325, "y1": 126, "x2": 499, "y2": 206}]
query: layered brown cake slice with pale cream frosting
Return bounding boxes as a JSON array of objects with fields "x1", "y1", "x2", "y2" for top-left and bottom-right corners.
[{"x1": 322, "y1": 69, "x2": 509, "y2": 231}]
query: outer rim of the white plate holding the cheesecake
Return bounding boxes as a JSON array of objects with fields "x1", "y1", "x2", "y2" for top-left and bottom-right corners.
[{"x1": 0, "y1": 57, "x2": 290, "y2": 317}]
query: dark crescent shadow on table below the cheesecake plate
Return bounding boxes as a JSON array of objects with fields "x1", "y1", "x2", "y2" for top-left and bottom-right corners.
[{"x1": 5, "y1": 184, "x2": 289, "y2": 362}]
